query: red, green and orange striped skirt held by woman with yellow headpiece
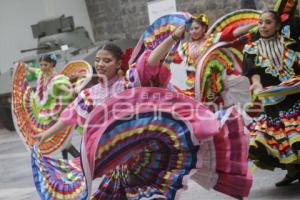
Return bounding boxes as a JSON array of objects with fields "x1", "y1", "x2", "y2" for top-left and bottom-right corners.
[{"x1": 195, "y1": 9, "x2": 260, "y2": 102}]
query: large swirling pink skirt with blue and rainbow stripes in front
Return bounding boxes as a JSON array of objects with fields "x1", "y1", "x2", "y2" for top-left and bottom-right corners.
[{"x1": 32, "y1": 88, "x2": 252, "y2": 200}]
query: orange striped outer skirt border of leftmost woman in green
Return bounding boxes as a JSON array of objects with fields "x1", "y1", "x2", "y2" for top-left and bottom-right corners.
[{"x1": 12, "y1": 63, "x2": 72, "y2": 154}]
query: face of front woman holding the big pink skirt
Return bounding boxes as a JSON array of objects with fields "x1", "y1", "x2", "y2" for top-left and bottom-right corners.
[{"x1": 95, "y1": 49, "x2": 120, "y2": 80}]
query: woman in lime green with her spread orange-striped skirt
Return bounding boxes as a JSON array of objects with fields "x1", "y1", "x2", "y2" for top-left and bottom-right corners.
[{"x1": 12, "y1": 53, "x2": 79, "y2": 159}]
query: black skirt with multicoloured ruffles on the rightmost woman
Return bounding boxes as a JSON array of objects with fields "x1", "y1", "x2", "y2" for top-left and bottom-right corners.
[{"x1": 249, "y1": 95, "x2": 300, "y2": 170}]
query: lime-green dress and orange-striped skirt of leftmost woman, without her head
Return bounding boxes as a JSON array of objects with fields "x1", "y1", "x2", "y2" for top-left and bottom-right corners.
[{"x1": 12, "y1": 60, "x2": 93, "y2": 154}]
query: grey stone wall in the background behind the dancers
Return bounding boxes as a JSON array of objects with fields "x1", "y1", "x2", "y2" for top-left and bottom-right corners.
[{"x1": 86, "y1": 0, "x2": 272, "y2": 41}]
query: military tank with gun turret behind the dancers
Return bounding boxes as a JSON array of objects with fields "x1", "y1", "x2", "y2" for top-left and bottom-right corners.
[{"x1": 0, "y1": 15, "x2": 137, "y2": 130}]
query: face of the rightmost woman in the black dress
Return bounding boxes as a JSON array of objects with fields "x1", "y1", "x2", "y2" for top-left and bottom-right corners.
[{"x1": 258, "y1": 12, "x2": 280, "y2": 38}]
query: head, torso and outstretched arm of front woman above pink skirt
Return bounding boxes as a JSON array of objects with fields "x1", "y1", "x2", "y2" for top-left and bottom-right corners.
[{"x1": 32, "y1": 43, "x2": 131, "y2": 141}]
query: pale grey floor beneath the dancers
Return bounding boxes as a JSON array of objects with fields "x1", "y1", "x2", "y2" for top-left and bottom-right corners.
[{"x1": 0, "y1": 130, "x2": 300, "y2": 200}]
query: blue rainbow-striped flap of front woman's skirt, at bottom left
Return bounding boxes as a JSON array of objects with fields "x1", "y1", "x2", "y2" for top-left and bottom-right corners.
[{"x1": 31, "y1": 145, "x2": 87, "y2": 200}]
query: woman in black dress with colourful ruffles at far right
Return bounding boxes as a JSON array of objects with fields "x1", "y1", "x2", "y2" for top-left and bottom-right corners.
[{"x1": 244, "y1": 11, "x2": 300, "y2": 186}]
